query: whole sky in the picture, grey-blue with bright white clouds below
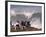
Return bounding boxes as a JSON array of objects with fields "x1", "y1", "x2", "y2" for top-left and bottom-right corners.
[{"x1": 10, "y1": 5, "x2": 42, "y2": 18}]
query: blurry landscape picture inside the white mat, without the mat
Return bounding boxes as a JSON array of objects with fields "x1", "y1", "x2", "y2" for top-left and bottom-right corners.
[{"x1": 10, "y1": 5, "x2": 42, "y2": 32}]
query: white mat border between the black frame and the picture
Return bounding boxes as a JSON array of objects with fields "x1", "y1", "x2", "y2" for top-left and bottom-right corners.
[{"x1": 8, "y1": 2, "x2": 44, "y2": 35}]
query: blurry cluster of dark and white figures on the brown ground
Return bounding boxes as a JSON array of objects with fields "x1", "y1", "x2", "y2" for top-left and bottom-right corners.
[{"x1": 10, "y1": 21, "x2": 31, "y2": 29}]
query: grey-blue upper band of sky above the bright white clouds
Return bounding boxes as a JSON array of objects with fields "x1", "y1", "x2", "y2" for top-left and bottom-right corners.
[{"x1": 10, "y1": 5, "x2": 42, "y2": 13}]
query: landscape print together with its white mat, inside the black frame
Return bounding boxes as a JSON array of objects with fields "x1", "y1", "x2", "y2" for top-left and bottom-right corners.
[{"x1": 7, "y1": 2, "x2": 44, "y2": 35}]
